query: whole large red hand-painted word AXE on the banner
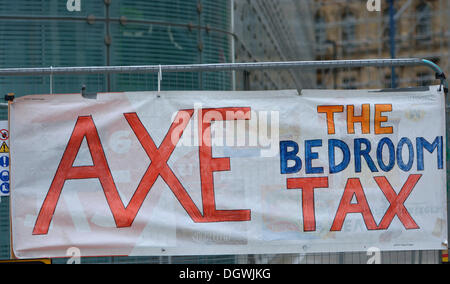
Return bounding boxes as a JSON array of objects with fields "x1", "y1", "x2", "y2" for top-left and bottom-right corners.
[{"x1": 33, "y1": 108, "x2": 250, "y2": 235}]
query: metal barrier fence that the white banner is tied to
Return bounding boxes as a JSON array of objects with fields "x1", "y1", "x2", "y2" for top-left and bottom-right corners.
[{"x1": 0, "y1": 58, "x2": 449, "y2": 264}]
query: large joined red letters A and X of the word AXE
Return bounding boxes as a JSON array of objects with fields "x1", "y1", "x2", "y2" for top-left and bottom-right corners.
[{"x1": 33, "y1": 110, "x2": 198, "y2": 235}]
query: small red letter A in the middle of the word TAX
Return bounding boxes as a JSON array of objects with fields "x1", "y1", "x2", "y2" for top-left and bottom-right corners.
[{"x1": 331, "y1": 178, "x2": 377, "y2": 231}]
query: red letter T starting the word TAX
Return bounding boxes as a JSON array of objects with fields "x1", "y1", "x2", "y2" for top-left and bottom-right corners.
[{"x1": 287, "y1": 177, "x2": 328, "y2": 232}]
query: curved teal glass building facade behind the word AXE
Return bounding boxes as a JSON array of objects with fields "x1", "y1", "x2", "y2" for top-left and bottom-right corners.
[{"x1": 0, "y1": 0, "x2": 232, "y2": 96}]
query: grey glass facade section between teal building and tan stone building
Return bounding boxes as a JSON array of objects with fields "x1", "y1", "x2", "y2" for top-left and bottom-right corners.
[{"x1": 233, "y1": 0, "x2": 315, "y2": 90}]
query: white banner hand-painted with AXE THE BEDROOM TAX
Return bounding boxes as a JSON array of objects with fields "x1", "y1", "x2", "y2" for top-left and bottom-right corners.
[{"x1": 10, "y1": 87, "x2": 447, "y2": 258}]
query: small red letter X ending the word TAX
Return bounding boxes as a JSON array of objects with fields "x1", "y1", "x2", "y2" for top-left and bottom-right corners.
[{"x1": 374, "y1": 175, "x2": 422, "y2": 230}]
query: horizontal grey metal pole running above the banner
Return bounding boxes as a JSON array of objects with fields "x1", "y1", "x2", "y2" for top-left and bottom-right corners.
[{"x1": 0, "y1": 58, "x2": 426, "y2": 76}]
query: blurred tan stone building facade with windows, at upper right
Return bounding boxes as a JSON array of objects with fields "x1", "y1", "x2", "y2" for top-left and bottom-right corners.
[{"x1": 313, "y1": 0, "x2": 450, "y2": 89}]
